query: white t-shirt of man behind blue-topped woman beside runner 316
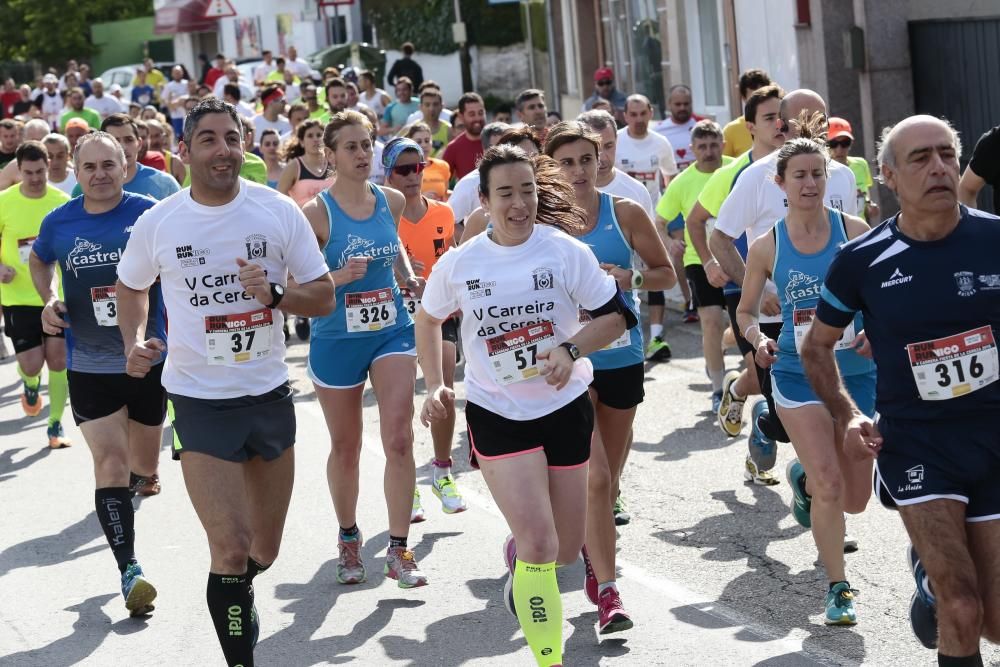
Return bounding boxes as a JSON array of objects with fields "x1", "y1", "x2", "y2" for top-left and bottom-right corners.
[{"x1": 715, "y1": 151, "x2": 858, "y2": 322}]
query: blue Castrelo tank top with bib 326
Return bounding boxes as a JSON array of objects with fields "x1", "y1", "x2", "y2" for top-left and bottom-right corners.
[{"x1": 312, "y1": 183, "x2": 413, "y2": 339}]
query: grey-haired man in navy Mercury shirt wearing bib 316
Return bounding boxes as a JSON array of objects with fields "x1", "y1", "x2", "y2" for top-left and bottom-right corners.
[{"x1": 802, "y1": 116, "x2": 1000, "y2": 666}]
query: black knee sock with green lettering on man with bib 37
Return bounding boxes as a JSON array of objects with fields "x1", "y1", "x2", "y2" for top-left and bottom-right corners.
[{"x1": 205, "y1": 572, "x2": 253, "y2": 667}]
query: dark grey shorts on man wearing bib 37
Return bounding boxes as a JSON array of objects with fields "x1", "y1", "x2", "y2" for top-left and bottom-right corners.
[{"x1": 169, "y1": 382, "x2": 295, "y2": 463}]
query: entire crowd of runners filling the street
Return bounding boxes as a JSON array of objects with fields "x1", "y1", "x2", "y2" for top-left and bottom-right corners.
[{"x1": 0, "y1": 48, "x2": 1000, "y2": 667}]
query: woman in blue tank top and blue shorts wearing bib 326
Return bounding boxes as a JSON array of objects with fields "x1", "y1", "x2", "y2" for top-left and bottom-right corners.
[{"x1": 303, "y1": 111, "x2": 427, "y2": 588}]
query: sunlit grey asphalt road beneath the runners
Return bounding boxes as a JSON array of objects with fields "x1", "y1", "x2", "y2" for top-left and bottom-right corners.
[{"x1": 0, "y1": 316, "x2": 1000, "y2": 667}]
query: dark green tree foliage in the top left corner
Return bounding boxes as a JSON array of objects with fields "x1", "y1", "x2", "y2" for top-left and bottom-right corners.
[{"x1": 0, "y1": 0, "x2": 153, "y2": 66}]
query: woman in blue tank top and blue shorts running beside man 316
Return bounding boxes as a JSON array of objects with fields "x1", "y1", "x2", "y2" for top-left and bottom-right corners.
[{"x1": 737, "y1": 119, "x2": 875, "y2": 625}]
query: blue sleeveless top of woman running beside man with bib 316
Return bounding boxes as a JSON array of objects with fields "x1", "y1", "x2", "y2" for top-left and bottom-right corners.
[{"x1": 772, "y1": 209, "x2": 875, "y2": 377}]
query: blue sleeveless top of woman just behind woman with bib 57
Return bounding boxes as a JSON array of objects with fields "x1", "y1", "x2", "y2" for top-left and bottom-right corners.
[{"x1": 577, "y1": 192, "x2": 644, "y2": 370}]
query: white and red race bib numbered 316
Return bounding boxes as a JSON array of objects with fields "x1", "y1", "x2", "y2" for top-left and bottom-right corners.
[{"x1": 906, "y1": 326, "x2": 1000, "y2": 401}]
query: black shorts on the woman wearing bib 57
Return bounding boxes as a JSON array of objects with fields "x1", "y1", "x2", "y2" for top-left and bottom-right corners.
[{"x1": 465, "y1": 392, "x2": 594, "y2": 468}]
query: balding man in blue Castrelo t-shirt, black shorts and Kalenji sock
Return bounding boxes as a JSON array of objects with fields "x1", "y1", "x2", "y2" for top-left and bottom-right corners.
[{"x1": 29, "y1": 132, "x2": 166, "y2": 616}]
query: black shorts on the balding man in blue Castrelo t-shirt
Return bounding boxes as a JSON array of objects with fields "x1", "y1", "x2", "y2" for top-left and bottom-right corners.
[{"x1": 66, "y1": 364, "x2": 167, "y2": 426}]
